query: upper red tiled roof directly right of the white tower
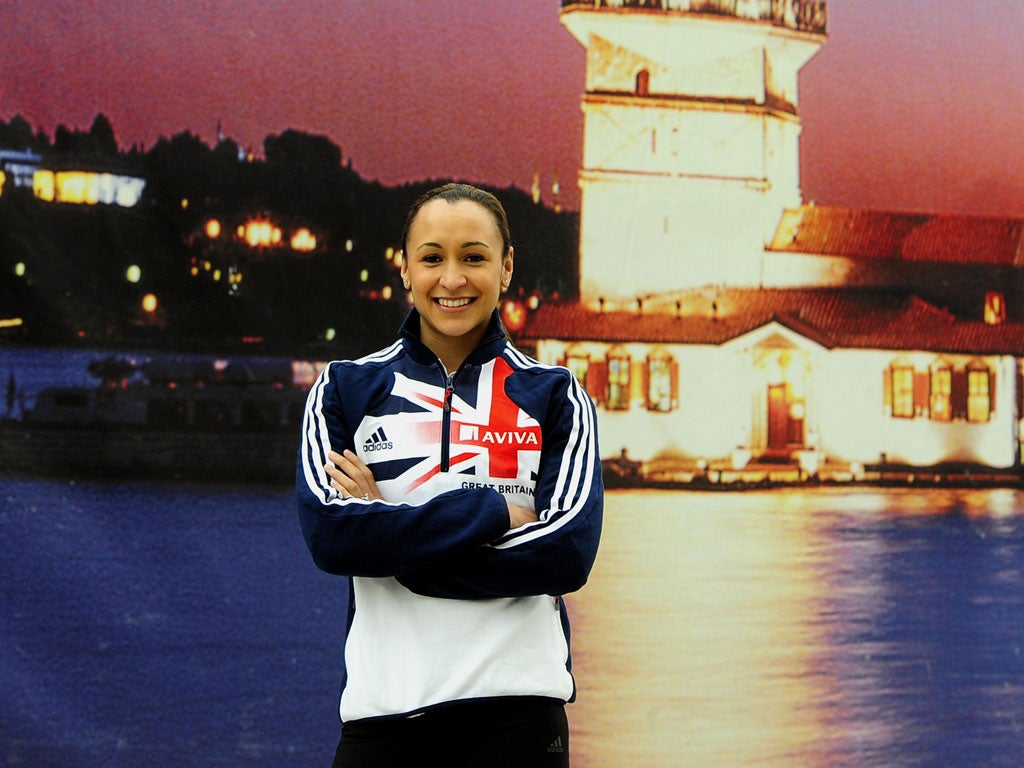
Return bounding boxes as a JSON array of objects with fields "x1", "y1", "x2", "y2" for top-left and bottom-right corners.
[{"x1": 768, "y1": 205, "x2": 1024, "y2": 266}]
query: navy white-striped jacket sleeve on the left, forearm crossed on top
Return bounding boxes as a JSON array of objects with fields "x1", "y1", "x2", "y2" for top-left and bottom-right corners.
[{"x1": 295, "y1": 362, "x2": 509, "y2": 577}]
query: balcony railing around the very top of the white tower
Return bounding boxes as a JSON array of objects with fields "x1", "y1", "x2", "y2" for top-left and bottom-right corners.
[{"x1": 562, "y1": 0, "x2": 827, "y2": 35}]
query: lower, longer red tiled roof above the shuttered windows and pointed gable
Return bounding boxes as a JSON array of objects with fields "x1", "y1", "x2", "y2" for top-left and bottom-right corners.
[{"x1": 518, "y1": 289, "x2": 1024, "y2": 356}]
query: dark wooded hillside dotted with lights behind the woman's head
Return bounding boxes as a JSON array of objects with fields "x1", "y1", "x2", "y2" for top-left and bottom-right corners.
[{"x1": 0, "y1": 115, "x2": 579, "y2": 355}]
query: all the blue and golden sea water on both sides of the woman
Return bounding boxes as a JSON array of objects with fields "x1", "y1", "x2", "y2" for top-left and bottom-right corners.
[{"x1": 0, "y1": 478, "x2": 1024, "y2": 768}]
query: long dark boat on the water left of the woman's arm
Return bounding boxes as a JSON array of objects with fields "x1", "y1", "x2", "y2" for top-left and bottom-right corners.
[{"x1": 0, "y1": 356, "x2": 311, "y2": 483}]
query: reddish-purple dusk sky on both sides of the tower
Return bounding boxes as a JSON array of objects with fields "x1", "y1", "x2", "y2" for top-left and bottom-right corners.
[{"x1": 0, "y1": 0, "x2": 1024, "y2": 216}]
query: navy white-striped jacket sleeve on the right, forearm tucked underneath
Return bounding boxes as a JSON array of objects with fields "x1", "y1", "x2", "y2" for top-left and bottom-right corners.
[{"x1": 398, "y1": 372, "x2": 604, "y2": 599}]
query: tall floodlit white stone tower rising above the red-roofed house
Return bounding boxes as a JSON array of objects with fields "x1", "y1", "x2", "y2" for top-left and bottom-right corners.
[{"x1": 560, "y1": 0, "x2": 826, "y2": 307}]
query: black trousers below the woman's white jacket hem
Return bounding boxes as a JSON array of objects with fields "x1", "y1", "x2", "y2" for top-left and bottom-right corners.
[{"x1": 333, "y1": 696, "x2": 569, "y2": 768}]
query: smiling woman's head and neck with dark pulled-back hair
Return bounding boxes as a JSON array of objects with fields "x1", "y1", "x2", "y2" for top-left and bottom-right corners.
[{"x1": 401, "y1": 200, "x2": 512, "y2": 371}]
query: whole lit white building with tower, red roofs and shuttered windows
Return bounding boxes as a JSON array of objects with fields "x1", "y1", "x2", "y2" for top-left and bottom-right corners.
[{"x1": 520, "y1": 0, "x2": 1024, "y2": 476}]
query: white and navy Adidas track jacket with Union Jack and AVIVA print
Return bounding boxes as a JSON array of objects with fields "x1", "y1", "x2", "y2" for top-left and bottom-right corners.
[{"x1": 296, "y1": 309, "x2": 603, "y2": 722}]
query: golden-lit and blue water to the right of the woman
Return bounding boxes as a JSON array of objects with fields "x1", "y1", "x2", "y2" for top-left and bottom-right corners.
[{"x1": 571, "y1": 489, "x2": 1024, "y2": 768}]
